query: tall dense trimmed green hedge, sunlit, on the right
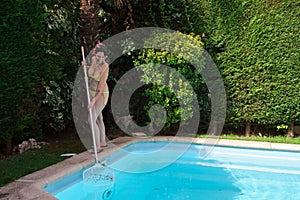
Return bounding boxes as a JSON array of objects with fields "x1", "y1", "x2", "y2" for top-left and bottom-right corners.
[{"x1": 202, "y1": 0, "x2": 300, "y2": 130}]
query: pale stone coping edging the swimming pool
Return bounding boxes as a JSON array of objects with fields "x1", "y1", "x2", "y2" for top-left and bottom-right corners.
[{"x1": 0, "y1": 136, "x2": 300, "y2": 200}]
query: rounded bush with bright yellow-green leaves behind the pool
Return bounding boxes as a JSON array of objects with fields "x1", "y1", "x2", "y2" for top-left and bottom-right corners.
[{"x1": 134, "y1": 32, "x2": 209, "y2": 127}]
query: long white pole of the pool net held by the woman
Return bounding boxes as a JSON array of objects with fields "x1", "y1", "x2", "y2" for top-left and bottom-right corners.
[{"x1": 81, "y1": 46, "x2": 99, "y2": 164}]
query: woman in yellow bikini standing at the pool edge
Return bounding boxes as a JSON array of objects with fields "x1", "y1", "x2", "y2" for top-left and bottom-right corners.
[{"x1": 88, "y1": 43, "x2": 109, "y2": 151}]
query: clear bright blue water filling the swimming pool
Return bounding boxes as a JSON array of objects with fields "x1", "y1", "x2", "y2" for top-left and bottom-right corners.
[{"x1": 44, "y1": 142, "x2": 300, "y2": 200}]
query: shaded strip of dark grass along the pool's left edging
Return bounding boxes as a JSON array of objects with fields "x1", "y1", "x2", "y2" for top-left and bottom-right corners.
[{"x1": 0, "y1": 134, "x2": 85, "y2": 187}]
